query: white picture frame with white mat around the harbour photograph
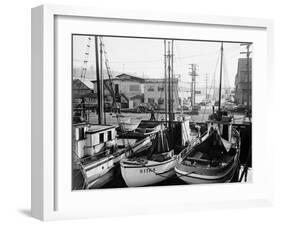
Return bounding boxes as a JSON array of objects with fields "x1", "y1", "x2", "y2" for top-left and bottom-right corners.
[{"x1": 31, "y1": 5, "x2": 274, "y2": 220}]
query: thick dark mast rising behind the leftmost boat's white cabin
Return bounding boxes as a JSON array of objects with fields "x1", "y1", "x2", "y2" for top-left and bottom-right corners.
[{"x1": 95, "y1": 36, "x2": 104, "y2": 124}]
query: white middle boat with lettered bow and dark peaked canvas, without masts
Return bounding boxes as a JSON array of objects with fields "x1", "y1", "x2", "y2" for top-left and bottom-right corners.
[{"x1": 120, "y1": 125, "x2": 177, "y2": 187}]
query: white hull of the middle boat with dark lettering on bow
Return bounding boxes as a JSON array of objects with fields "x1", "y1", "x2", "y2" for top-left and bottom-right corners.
[{"x1": 120, "y1": 156, "x2": 177, "y2": 187}]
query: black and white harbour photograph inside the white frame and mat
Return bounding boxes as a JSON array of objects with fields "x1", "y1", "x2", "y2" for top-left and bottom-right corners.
[{"x1": 70, "y1": 34, "x2": 254, "y2": 190}]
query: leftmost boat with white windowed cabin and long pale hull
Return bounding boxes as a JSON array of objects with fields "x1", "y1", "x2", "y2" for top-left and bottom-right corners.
[{"x1": 73, "y1": 123, "x2": 158, "y2": 189}]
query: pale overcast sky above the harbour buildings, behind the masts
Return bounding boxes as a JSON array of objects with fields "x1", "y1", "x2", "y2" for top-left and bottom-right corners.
[{"x1": 73, "y1": 35, "x2": 249, "y2": 87}]
